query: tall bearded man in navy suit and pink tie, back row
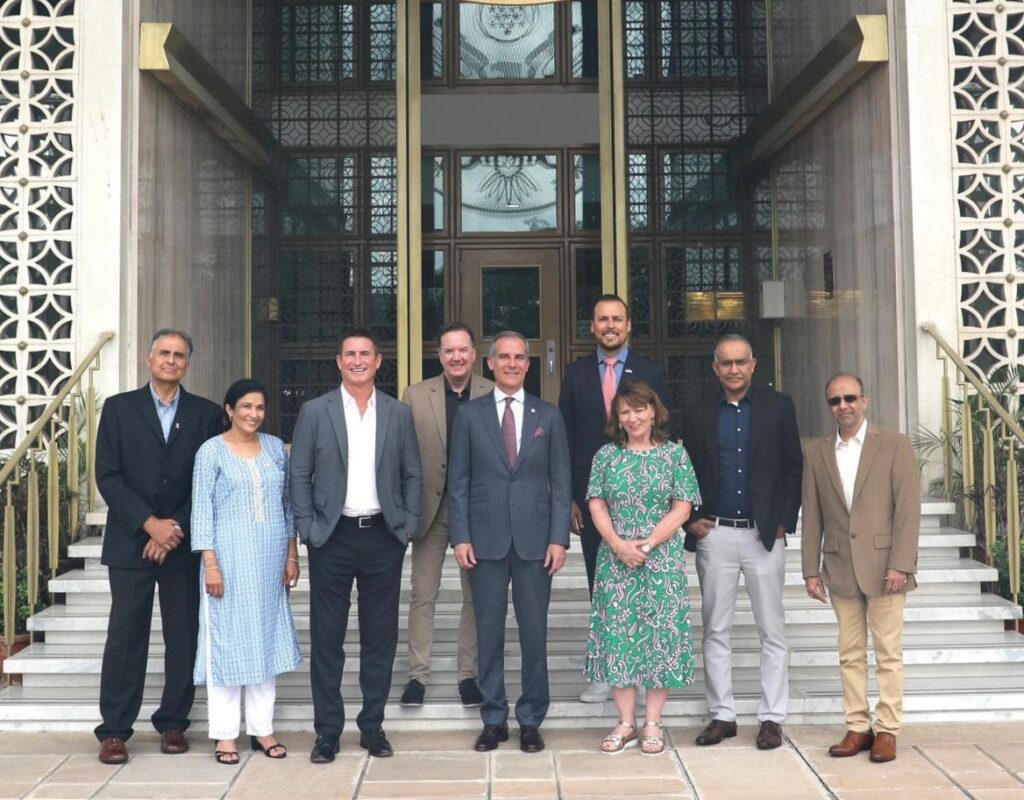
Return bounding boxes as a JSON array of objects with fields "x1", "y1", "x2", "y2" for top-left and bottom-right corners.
[{"x1": 558, "y1": 294, "x2": 672, "y2": 703}]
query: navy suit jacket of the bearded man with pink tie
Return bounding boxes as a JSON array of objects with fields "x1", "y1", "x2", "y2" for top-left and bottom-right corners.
[{"x1": 558, "y1": 349, "x2": 672, "y2": 508}]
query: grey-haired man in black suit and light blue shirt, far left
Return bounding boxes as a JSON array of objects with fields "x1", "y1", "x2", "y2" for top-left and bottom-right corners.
[{"x1": 96, "y1": 329, "x2": 223, "y2": 764}]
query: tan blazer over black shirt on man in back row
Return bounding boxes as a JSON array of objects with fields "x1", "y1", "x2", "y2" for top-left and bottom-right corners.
[{"x1": 401, "y1": 374, "x2": 495, "y2": 536}]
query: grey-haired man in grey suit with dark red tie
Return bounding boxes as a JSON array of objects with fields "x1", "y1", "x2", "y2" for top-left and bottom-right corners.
[{"x1": 449, "y1": 331, "x2": 572, "y2": 753}]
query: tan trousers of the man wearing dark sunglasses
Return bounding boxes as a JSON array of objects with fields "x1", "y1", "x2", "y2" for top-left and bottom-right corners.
[{"x1": 831, "y1": 593, "x2": 906, "y2": 735}]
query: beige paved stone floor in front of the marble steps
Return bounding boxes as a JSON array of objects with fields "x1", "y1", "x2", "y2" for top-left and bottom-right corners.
[{"x1": 0, "y1": 722, "x2": 1024, "y2": 800}]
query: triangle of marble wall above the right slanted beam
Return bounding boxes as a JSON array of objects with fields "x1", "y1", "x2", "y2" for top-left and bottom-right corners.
[{"x1": 770, "y1": 0, "x2": 884, "y2": 92}]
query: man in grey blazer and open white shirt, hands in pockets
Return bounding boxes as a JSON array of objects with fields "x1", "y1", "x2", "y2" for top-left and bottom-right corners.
[{"x1": 290, "y1": 329, "x2": 422, "y2": 764}]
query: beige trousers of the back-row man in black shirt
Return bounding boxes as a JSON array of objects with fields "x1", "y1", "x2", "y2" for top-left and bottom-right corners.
[{"x1": 409, "y1": 492, "x2": 476, "y2": 684}]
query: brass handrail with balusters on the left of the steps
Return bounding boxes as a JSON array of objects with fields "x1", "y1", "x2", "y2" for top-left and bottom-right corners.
[{"x1": 0, "y1": 332, "x2": 115, "y2": 681}]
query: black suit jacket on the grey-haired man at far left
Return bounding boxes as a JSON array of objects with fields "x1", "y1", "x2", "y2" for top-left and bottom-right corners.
[{"x1": 96, "y1": 383, "x2": 223, "y2": 570}]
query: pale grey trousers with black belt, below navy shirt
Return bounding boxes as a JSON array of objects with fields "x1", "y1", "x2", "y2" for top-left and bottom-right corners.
[{"x1": 697, "y1": 523, "x2": 790, "y2": 723}]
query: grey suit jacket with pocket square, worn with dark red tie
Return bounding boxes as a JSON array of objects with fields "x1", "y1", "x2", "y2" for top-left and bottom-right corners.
[{"x1": 449, "y1": 392, "x2": 572, "y2": 560}]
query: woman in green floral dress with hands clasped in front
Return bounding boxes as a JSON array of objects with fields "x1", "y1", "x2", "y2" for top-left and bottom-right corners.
[{"x1": 586, "y1": 381, "x2": 700, "y2": 755}]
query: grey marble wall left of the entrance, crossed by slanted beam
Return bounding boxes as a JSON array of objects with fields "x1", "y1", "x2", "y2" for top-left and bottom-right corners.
[{"x1": 135, "y1": 0, "x2": 250, "y2": 402}]
